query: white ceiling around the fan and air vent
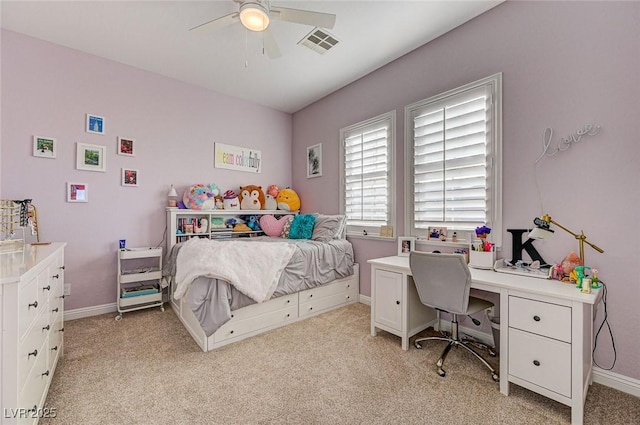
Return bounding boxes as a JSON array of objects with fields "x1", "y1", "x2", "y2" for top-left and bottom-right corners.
[{"x1": 0, "y1": 0, "x2": 502, "y2": 113}]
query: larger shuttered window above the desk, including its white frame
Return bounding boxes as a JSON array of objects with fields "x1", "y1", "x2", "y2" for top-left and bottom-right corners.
[{"x1": 405, "y1": 74, "x2": 502, "y2": 246}]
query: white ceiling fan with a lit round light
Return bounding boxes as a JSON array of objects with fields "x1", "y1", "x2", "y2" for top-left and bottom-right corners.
[{"x1": 189, "y1": 0, "x2": 336, "y2": 59}]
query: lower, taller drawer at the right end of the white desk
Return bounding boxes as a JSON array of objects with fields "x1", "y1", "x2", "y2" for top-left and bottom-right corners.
[{"x1": 509, "y1": 329, "x2": 571, "y2": 397}]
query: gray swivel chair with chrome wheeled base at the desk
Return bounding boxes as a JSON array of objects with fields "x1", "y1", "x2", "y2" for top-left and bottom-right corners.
[{"x1": 409, "y1": 251, "x2": 500, "y2": 382}]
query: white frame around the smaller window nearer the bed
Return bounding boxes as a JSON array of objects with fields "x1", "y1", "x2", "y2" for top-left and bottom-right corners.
[{"x1": 340, "y1": 109, "x2": 397, "y2": 235}]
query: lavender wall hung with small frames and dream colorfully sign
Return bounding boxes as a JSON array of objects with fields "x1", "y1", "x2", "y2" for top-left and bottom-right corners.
[{"x1": 0, "y1": 31, "x2": 292, "y2": 309}]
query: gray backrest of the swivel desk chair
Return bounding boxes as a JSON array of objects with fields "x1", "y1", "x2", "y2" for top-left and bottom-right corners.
[{"x1": 409, "y1": 251, "x2": 471, "y2": 314}]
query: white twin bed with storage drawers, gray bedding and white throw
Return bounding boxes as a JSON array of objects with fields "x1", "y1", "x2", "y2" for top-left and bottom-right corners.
[{"x1": 163, "y1": 216, "x2": 359, "y2": 351}]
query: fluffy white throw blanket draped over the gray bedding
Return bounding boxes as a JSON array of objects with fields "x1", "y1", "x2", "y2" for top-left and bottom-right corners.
[{"x1": 174, "y1": 238, "x2": 295, "y2": 302}]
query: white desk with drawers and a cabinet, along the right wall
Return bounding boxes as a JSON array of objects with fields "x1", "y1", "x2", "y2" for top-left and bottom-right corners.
[{"x1": 368, "y1": 256, "x2": 601, "y2": 424}]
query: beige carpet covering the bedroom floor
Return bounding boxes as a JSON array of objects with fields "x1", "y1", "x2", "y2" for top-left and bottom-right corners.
[{"x1": 40, "y1": 304, "x2": 640, "y2": 425}]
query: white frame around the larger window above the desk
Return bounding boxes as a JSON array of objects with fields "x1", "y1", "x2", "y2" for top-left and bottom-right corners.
[{"x1": 404, "y1": 73, "x2": 503, "y2": 247}]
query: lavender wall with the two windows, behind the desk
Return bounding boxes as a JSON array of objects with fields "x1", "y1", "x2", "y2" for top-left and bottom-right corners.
[{"x1": 293, "y1": 2, "x2": 640, "y2": 379}]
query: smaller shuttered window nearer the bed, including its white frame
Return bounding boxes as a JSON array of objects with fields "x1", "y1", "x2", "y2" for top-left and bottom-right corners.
[{"x1": 340, "y1": 111, "x2": 396, "y2": 235}]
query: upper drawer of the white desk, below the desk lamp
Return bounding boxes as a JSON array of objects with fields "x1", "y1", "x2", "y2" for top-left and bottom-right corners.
[{"x1": 509, "y1": 296, "x2": 571, "y2": 342}]
